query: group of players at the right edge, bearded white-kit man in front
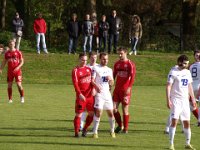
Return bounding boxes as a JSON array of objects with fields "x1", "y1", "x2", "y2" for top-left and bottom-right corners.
[{"x1": 165, "y1": 50, "x2": 200, "y2": 150}]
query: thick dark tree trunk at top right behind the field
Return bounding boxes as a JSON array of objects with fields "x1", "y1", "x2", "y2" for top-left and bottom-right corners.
[{"x1": 182, "y1": 0, "x2": 198, "y2": 50}]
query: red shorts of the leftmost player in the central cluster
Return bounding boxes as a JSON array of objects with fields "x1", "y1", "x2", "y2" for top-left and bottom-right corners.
[{"x1": 75, "y1": 96, "x2": 94, "y2": 113}]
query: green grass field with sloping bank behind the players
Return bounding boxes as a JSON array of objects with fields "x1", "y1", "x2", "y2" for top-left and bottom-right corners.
[{"x1": 0, "y1": 51, "x2": 200, "y2": 150}]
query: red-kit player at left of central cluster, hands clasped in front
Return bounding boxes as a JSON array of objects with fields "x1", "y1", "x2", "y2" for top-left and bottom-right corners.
[{"x1": 72, "y1": 53, "x2": 94, "y2": 137}]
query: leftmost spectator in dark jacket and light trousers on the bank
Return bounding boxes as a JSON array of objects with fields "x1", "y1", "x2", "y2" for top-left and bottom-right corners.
[{"x1": 12, "y1": 12, "x2": 24, "y2": 50}]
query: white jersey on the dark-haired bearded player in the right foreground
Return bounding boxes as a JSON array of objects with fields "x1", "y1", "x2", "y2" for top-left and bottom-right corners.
[{"x1": 167, "y1": 66, "x2": 192, "y2": 101}]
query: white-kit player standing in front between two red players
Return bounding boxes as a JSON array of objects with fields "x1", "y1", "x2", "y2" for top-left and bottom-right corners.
[{"x1": 92, "y1": 53, "x2": 115, "y2": 138}]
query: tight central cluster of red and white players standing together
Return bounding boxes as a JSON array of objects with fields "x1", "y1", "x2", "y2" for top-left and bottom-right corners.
[{"x1": 72, "y1": 47, "x2": 136, "y2": 138}]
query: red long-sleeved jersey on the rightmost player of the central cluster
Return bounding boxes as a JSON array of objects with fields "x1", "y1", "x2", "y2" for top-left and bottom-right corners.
[{"x1": 113, "y1": 60, "x2": 136, "y2": 90}]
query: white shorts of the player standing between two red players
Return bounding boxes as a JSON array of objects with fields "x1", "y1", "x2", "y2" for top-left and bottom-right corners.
[{"x1": 94, "y1": 94, "x2": 113, "y2": 110}]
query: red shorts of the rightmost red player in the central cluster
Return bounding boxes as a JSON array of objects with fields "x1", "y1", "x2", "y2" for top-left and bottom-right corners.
[{"x1": 113, "y1": 90, "x2": 131, "y2": 105}]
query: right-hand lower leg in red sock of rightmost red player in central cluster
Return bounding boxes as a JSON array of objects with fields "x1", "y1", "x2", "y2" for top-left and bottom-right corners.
[{"x1": 122, "y1": 104, "x2": 130, "y2": 133}]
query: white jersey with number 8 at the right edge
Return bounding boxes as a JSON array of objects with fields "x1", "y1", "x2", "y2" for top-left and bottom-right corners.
[{"x1": 190, "y1": 62, "x2": 200, "y2": 91}]
